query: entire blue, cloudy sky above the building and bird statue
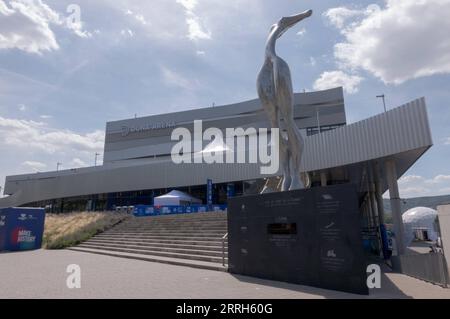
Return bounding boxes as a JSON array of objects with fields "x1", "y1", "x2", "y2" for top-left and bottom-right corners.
[{"x1": 0, "y1": 0, "x2": 450, "y2": 197}]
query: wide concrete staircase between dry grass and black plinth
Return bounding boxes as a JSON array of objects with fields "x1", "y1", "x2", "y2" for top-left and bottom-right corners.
[{"x1": 70, "y1": 212, "x2": 228, "y2": 271}]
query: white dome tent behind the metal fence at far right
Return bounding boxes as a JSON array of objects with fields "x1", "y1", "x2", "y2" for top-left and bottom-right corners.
[{"x1": 402, "y1": 207, "x2": 439, "y2": 246}]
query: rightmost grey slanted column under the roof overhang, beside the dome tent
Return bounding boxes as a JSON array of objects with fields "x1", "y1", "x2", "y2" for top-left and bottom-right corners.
[{"x1": 385, "y1": 159, "x2": 405, "y2": 255}]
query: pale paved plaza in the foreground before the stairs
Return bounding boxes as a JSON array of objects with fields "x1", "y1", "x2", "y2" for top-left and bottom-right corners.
[{"x1": 0, "y1": 250, "x2": 450, "y2": 298}]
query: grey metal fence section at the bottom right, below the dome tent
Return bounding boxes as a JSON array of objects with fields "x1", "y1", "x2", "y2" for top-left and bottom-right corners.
[{"x1": 400, "y1": 252, "x2": 450, "y2": 288}]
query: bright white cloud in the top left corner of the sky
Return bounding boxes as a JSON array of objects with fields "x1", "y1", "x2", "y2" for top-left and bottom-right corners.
[{"x1": 0, "y1": 0, "x2": 92, "y2": 54}]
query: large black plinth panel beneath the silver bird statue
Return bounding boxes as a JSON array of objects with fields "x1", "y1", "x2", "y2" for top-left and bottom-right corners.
[{"x1": 228, "y1": 184, "x2": 368, "y2": 294}]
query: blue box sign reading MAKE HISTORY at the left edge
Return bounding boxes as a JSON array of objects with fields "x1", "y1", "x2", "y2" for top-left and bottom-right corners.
[{"x1": 0, "y1": 208, "x2": 45, "y2": 251}]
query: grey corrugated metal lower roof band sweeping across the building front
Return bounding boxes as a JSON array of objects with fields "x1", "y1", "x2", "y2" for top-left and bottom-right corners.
[{"x1": 0, "y1": 98, "x2": 432, "y2": 207}]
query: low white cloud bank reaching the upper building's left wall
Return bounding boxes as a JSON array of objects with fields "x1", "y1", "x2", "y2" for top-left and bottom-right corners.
[{"x1": 0, "y1": 117, "x2": 104, "y2": 154}]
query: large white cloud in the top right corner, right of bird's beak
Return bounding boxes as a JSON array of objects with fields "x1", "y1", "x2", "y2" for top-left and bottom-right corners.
[{"x1": 324, "y1": 0, "x2": 450, "y2": 84}]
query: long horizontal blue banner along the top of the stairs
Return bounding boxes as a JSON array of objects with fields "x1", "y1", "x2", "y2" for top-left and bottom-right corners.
[{"x1": 133, "y1": 205, "x2": 227, "y2": 217}]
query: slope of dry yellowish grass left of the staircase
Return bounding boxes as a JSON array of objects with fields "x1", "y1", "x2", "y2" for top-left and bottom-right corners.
[{"x1": 42, "y1": 212, "x2": 129, "y2": 249}]
